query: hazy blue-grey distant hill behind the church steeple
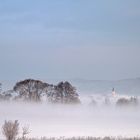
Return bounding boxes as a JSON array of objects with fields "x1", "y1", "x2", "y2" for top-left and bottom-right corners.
[{"x1": 71, "y1": 78, "x2": 140, "y2": 95}]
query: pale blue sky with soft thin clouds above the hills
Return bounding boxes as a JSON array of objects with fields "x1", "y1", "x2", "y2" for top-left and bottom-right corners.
[{"x1": 0, "y1": 0, "x2": 140, "y2": 80}]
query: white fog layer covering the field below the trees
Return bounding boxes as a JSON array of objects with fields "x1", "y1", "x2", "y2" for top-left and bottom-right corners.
[{"x1": 0, "y1": 99, "x2": 140, "y2": 138}]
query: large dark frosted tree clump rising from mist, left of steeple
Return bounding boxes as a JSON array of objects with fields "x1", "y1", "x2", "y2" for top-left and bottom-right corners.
[{"x1": 0, "y1": 79, "x2": 80, "y2": 103}]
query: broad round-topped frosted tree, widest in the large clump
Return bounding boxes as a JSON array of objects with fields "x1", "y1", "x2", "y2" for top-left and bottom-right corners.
[{"x1": 13, "y1": 79, "x2": 48, "y2": 101}]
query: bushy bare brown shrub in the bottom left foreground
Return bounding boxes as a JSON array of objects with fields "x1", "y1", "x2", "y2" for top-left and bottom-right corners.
[{"x1": 2, "y1": 120, "x2": 19, "y2": 140}]
